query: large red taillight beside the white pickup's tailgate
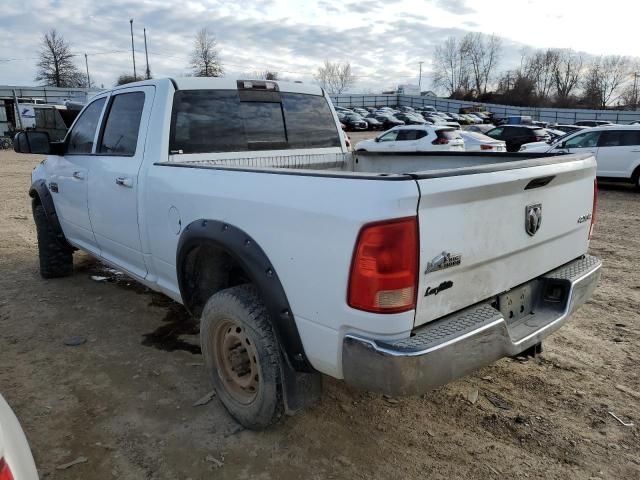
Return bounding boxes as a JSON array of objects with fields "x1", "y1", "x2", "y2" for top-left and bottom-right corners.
[{"x1": 347, "y1": 217, "x2": 418, "y2": 313}]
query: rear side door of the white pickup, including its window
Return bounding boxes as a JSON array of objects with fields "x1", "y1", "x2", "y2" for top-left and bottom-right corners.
[{"x1": 88, "y1": 86, "x2": 155, "y2": 278}]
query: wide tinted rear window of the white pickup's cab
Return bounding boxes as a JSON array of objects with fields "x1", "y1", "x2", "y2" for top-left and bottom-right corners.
[{"x1": 170, "y1": 90, "x2": 340, "y2": 153}]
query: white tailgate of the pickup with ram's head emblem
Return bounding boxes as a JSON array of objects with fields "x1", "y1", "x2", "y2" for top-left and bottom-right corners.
[{"x1": 415, "y1": 155, "x2": 596, "y2": 326}]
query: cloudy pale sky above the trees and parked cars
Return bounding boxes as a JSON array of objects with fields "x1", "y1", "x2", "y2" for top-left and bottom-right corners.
[{"x1": 0, "y1": 0, "x2": 640, "y2": 92}]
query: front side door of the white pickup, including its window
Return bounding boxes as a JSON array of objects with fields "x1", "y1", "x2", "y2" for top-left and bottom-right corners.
[{"x1": 45, "y1": 97, "x2": 106, "y2": 253}]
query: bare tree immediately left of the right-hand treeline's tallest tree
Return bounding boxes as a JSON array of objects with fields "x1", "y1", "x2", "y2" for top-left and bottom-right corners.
[{"x1": 433, "y1": 37, "x2": 472, "y2": 96}]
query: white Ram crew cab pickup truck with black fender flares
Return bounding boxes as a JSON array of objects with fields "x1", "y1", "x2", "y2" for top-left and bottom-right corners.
[{"x1": 15, "y1": 78, "x2": 600, "y2": 428}]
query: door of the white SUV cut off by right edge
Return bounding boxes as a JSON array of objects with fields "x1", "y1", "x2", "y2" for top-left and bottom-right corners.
[{"x1": 597, "y1": 130, "x2": 640, "y2": 177}]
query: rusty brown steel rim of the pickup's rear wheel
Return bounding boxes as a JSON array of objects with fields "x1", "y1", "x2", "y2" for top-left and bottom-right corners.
[{"x1": 213, "y1": 320, "x2": 260, "y2": 405}]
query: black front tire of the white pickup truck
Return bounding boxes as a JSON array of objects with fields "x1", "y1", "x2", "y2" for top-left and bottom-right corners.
[{"x1": 32, "y1": 202, "x2": 73, "y2": 278}]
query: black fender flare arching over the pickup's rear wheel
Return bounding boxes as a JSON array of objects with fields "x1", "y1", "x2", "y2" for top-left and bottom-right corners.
[{"x1": 176, "y1": 219, "x2": 315, "y2": 372}]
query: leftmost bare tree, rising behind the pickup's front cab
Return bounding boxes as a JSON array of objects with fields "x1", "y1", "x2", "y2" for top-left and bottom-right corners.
[{"x1": 35, "y1": 29, "x2": 86, "y2": 87}]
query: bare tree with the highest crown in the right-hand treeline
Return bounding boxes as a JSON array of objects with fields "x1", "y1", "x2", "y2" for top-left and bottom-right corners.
[{"x1": 459, "y1": 33, "x2": 502, "y2": 95}]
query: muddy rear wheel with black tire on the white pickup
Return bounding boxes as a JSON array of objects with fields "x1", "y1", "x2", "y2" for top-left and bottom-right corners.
[{"x1": 200, "y1": 285, "x2": 284, "y2": 430}]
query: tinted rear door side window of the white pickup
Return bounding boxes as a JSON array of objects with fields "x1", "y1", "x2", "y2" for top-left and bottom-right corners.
[{"x1": 98, "y1": 92, "x2": 144, "y2": 156}]
